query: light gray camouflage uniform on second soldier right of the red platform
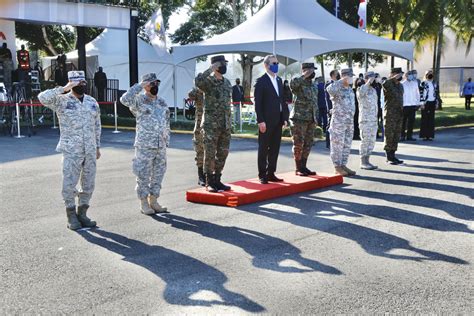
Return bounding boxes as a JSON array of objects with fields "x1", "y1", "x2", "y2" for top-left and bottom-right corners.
[{"x1": 357, "y1": 84, "x2": 378, "y2": 157}]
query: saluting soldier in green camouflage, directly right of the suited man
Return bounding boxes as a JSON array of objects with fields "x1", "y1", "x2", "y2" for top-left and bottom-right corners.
[{"x1": 290, "y1": 63, "x2": 318, "y2": 176}]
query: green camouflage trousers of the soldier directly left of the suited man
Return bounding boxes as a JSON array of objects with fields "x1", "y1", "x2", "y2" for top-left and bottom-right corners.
[{"x1": 202, "y1": 128, "x2": 231, "y2": 174}]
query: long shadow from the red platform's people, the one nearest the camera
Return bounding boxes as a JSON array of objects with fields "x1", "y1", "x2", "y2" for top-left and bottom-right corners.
[{"x1": 239, "y1": 200, "x2": 467, "y2": 264}]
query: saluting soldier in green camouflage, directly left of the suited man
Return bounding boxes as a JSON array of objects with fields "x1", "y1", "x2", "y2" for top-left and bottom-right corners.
[{"x1": 195, "y1": 55, "x2": 232, "y2": 192}]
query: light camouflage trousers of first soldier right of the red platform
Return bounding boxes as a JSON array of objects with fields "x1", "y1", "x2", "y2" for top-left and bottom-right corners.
[{"x1": 329, "y1": 117, "x2": 354, "y2": 167}]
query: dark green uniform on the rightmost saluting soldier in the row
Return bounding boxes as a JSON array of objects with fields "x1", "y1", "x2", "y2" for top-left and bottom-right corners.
[{"x1": 383, "y1": 78, "x2": 403, "y2": 151}]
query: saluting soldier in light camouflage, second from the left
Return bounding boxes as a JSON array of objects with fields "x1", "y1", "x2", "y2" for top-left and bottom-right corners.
[{"x1": 120, "y1": 73, "x2": 170, "y2": 215}]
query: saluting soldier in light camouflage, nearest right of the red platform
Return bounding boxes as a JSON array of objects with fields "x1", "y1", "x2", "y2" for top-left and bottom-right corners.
[{"x1": 326, "y1": 68, "x2": 356, "y2": 176}]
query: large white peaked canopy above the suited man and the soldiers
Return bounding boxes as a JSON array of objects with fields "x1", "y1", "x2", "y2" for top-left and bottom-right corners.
[{"x1": 173, "y1": 0, "x2": 413, "y2": 63}]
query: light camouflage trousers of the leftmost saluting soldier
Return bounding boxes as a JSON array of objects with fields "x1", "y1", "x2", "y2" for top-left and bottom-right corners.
[{"x1": 62, "y1": 152, "x2": 97, "y2": 207}]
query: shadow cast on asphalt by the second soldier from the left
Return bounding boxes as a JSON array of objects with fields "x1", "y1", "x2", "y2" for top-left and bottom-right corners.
[{"x1": 152, "y1": 214, "x2": 341, "y2": 275}]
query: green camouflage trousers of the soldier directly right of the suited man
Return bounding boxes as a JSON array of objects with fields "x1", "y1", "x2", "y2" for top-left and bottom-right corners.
[{"x1": 291, "y1": 120, "x2": 316, "y2": 160}]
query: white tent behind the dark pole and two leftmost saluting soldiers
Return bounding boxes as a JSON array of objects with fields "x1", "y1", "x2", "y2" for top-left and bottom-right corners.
[{"x1": 42, "y1": 29, "x2": 196, "y2": 108}]
